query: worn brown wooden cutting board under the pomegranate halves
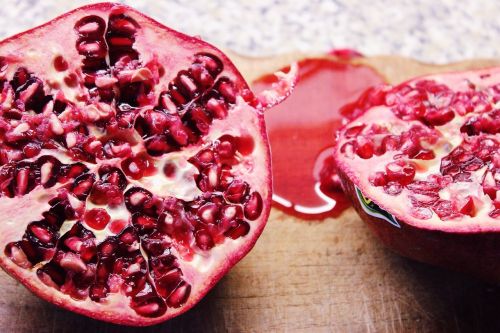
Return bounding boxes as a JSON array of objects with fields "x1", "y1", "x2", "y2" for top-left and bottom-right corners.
[{"x1": 0, "y1": 54, "x2": 500, "y2": 333}]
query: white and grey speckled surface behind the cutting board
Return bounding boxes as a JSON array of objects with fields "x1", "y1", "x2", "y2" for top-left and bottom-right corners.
[{"x1": 0, "y1": 0, "x2": 500, "y2": 63}]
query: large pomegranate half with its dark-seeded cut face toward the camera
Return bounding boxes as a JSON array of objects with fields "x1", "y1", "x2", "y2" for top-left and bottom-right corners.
[{"x1": 0, "y1": 3, "x2": 271, "y2": 326}]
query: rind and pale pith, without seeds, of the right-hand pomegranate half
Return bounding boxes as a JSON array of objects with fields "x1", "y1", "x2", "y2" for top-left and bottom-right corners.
[{"x1": 334, "y1": 68, "x2": 500, "y2": 282}]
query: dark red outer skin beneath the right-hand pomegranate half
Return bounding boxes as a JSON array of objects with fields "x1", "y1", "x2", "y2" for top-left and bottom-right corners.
[{"x1": 338, "y1": 170, "x2": 500, "y2": 283}]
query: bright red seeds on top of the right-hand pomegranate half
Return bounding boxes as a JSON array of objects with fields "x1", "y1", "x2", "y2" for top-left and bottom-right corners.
[{"x1": 339, "y1": 75, "x2": 500, "y2": 220}]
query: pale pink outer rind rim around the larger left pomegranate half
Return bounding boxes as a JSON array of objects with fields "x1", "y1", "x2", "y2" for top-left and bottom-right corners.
[{"x1": 0, "y1": 3, "x2": 272, "y2": 326}]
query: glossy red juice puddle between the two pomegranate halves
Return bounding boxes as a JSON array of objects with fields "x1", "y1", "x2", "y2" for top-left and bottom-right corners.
[{"x1": 253, "y1": 59, "x2": 384, "y2": 219}]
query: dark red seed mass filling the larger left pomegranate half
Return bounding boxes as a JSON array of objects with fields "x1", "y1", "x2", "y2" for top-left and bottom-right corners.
[{"x1": 0, "y1": 5, "x2": 264, "y2": 318}]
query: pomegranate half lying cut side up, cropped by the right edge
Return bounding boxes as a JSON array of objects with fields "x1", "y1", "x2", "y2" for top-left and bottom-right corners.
[{"x1": 334, "y1": 68, "x2": 500, "y2": 282}]
